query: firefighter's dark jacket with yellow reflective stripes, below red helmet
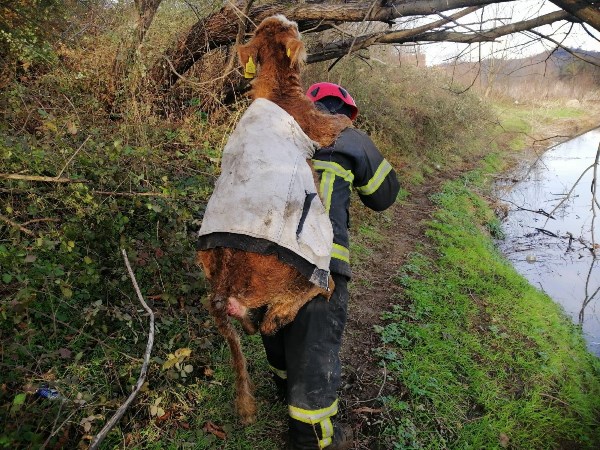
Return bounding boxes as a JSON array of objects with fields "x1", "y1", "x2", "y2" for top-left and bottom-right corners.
[{"x1": 313, "y1": 128, "x2": 400, "y2": 277}]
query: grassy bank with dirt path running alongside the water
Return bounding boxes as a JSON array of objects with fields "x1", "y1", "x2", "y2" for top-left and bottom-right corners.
[{"x1": 346, "y1": 100, "x2": 600, "y2": 449}]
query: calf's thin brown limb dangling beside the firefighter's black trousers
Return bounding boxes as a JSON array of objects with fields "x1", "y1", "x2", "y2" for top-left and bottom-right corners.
[{"x1": 209, "y1": 295, "x2": 256, "y2": 425}]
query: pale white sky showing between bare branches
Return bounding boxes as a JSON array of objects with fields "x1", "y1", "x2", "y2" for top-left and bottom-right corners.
[{"x1": 414, "y1": 0, "x2": 600, "y2": 65}]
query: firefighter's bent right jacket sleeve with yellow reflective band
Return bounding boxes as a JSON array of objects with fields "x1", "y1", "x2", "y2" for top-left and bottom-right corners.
[{"x1": 335, "y1": 128, "x2": 400, "y2": 211}]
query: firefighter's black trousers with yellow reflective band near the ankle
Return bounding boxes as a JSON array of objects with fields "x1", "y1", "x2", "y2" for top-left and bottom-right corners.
[{"x1": 262, "y1": 274, "x2": 348, "y2": 449}]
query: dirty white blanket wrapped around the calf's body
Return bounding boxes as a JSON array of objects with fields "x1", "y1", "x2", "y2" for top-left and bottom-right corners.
[{"x1": 199, "y1": 98, "x2": 333, "y2": 285}]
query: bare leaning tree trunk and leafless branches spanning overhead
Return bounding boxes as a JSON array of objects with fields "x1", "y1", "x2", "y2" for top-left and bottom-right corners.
[{"x1": 137, "y1": 0, "x2": 600, "y2": 89}]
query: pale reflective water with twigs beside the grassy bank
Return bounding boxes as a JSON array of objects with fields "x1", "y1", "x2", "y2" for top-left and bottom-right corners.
[{"x1": 497, "y1": 128, "x2": 600, "y2": 356}]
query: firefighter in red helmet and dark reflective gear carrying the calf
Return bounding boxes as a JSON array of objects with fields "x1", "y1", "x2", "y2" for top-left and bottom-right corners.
[{"x1": 262, "y1": 82, "x2": 399, "y2": 450}]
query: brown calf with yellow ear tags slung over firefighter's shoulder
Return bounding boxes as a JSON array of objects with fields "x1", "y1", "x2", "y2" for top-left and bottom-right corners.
[{"x1": 196, "y1": 15, "x2": 351, "y2": 424}]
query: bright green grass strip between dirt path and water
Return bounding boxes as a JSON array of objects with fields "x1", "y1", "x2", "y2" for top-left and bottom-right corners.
[{"x1": 378, "y1": 158, "x2": 600, "y2": 449}]
